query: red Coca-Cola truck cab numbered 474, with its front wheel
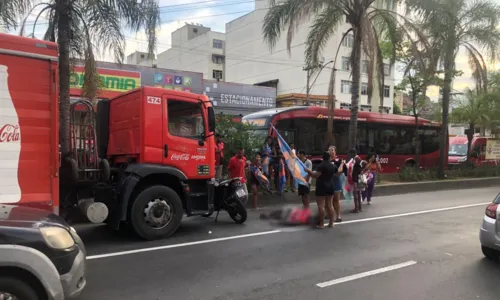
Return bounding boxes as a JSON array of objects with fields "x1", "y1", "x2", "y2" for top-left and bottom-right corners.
[{"x1": 94, "y1": 87, "x2": 215, "y2": 239}]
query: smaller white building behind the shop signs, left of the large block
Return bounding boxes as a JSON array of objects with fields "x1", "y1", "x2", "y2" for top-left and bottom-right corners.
[{"x1": 156, "y1": 24, "x2": 226, "y2": 81}]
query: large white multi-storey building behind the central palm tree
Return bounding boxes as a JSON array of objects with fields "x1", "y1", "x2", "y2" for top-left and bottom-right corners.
[{"x1": 225, "y1": 0, "x2": 394, "y2": 113}]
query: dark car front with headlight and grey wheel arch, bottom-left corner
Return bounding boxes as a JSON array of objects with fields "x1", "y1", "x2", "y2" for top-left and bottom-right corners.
[{"x1": 0, "y1": 205, "x2": 86, "y2": 300}]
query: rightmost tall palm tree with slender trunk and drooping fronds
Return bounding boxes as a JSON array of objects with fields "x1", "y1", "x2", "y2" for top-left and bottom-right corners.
[{"x1": 406, "y1": 0, "x2": 500, "y2": 178}]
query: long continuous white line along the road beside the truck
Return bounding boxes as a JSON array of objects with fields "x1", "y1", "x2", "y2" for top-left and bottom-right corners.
[{"x1": 87, "y1": 202, "x2": 491, "y2": 260}]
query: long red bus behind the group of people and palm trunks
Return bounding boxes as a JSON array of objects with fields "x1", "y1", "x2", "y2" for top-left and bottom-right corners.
[{"x1": 242, "y1": 106, "x2": 441, "y2": 173}]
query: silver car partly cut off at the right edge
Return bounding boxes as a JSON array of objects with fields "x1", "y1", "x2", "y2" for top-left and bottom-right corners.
[{"x1": 479, "y1": 194, "x2": 500, "y2": 260}]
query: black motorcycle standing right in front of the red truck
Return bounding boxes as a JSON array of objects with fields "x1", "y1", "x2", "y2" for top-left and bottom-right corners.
[{"x1": 204, "y1": 177, "x2": 248, "y2": 224}]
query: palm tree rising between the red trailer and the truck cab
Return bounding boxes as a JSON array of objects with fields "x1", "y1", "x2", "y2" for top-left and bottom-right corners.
[{"x1": 0, "y1": 0, "x2": 160, "y2": 158}]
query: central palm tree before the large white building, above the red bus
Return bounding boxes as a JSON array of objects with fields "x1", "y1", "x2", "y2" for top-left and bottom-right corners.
[{"x1": 263, "y1": 0, "x2": 406, "y2": 148}]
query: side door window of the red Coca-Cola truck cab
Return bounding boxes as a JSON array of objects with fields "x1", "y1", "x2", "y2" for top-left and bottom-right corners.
[{"x1": 167, "y1": 99, "x2": 205, "y2": 139}]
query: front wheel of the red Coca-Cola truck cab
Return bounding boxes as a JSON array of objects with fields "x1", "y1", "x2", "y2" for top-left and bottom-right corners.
[{"x1": 130, "y1": 185, "x2": 183, "y2": 240}]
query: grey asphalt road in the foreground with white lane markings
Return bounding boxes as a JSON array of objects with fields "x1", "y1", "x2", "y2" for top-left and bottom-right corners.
[{"x1": 77, "y1": 188, "x2": 500, "y2": 300}]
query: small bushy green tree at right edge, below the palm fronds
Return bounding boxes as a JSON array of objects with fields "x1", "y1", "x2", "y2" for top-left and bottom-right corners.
[{"x1": 451, "y1": 89, "x2": 498, "y2": 162}]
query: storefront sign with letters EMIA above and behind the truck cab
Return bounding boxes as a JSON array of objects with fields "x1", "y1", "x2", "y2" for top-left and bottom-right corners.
[{"x1": 70, "y1": 66, "x2": 141, "y2": 93}]
